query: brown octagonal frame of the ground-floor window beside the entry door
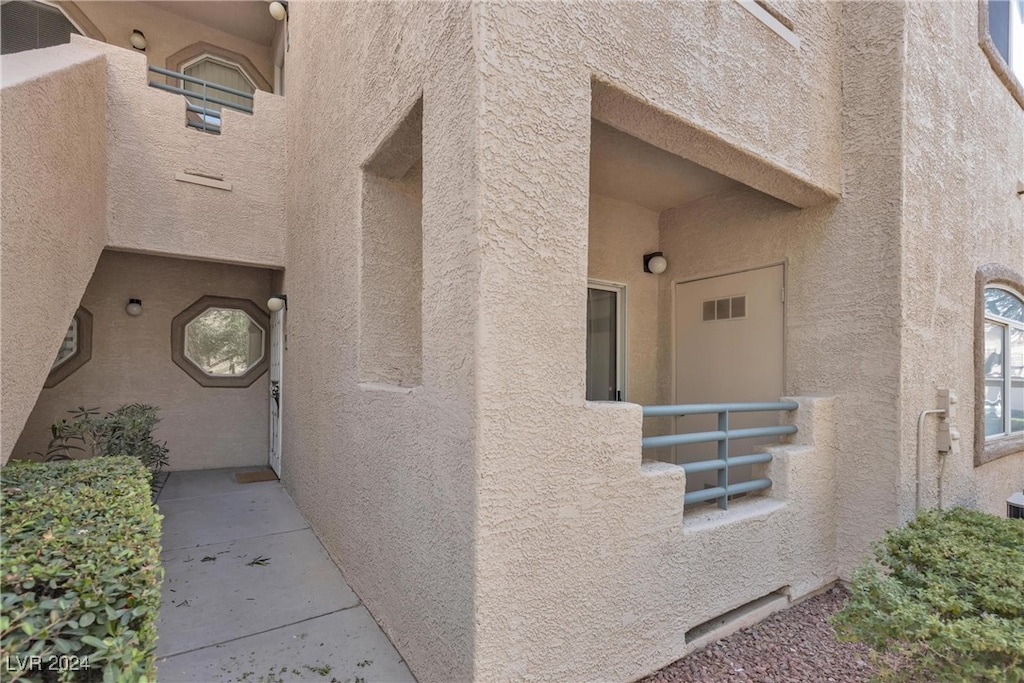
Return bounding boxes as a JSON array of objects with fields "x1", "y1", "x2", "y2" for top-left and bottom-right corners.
[{"x1": 171, "y1": 296, "x2": 270, "y2": 389}]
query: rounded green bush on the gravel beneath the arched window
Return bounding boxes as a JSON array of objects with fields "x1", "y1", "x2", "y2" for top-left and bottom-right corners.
[{"x1": 833, "y1": 508, "x2": 1024, "y2": 683}]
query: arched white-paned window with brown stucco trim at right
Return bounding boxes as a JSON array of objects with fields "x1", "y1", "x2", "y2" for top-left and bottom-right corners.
[{"x1": 975, "y1": 263, "x2": 1024, "y2": 465}]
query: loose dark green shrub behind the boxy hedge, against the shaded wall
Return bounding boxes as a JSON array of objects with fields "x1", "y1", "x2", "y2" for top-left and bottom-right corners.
[{"x1": 37, "y1": 403, "x2": 167, "y2": 475}]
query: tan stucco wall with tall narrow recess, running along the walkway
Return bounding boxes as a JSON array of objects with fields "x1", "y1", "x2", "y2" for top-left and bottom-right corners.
[{"x1": 283, "y1": 2, "x2": 479, "y2": 681}]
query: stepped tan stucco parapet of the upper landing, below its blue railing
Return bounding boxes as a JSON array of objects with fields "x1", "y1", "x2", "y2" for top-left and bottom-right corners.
[{"x1": 75, "y1": 38, "x2": 285, "y2": 267}]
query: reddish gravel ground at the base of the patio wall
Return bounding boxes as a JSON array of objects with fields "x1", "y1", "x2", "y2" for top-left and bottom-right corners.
[{"x1": 641, "y1": 586, "x2": 897, "y2": 683}]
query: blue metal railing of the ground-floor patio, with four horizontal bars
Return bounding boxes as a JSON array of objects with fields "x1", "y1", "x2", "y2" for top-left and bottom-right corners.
[{"x1": 642, "y1": 400, "x2": 798, "y2": 510}]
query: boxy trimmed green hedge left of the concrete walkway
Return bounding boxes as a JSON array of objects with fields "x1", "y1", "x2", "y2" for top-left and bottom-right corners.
[{"x1": 0, "y1": 457, "x2": 163, "y2": 682}]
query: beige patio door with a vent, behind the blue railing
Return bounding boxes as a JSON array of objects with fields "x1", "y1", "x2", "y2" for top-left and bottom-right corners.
[{"x1": 674, "y1": 265, "x2": 784, "y2": 490}]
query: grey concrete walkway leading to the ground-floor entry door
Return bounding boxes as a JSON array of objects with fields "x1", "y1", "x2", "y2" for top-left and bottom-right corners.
[{"x1": 157, "y1": 470, "x2": 415, "y2": 683}]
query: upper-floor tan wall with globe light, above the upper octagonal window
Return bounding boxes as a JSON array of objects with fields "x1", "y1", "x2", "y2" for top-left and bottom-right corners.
[{"x1": 76, "y1": 0, "x2": 273, "y2": 89}]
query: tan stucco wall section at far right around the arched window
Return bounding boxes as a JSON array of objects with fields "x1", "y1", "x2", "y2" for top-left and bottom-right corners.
[{"x1": 899, "y1": 2, "x2": 1024, "y2": 519}]
